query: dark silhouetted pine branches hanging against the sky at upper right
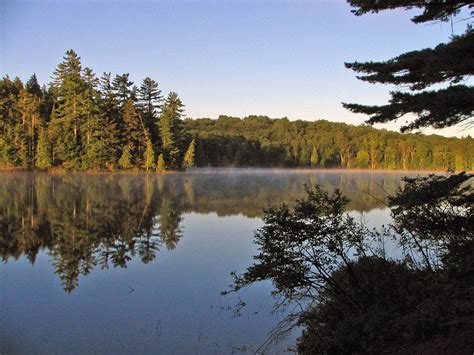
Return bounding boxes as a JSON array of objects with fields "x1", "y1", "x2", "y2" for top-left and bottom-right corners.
[{"x1": 343, "y1": 0, "x2": 474, "y2": 131}]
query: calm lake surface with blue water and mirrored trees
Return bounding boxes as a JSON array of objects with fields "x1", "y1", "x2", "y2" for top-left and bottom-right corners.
[{"x1": 0, "y1": 169, "x2": 422, "y2": 354}]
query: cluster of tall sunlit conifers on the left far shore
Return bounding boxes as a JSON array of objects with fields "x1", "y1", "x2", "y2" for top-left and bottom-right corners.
[{"x1": 0, "y1": 50, "x2": 188, "y2": 170}]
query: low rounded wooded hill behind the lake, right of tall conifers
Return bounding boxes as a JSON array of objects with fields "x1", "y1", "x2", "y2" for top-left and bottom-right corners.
[{"x1": 185, "y1": 116, "x2": 474, "y2": 170}]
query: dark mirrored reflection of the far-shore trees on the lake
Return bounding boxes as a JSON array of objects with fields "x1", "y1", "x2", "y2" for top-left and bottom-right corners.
[{"x1": 0, "y1": 170, "x2": 414, "y2": 292}]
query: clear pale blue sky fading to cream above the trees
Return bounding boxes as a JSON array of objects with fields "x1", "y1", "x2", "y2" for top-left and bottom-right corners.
[{"x1": 0, "y1": 0, "x2": 474, "y2": 136}]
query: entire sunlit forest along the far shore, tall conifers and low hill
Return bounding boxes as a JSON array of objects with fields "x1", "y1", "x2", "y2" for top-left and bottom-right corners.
[{"x1": 0, "y1": 50, "x2": 474, "y2": 171}]
